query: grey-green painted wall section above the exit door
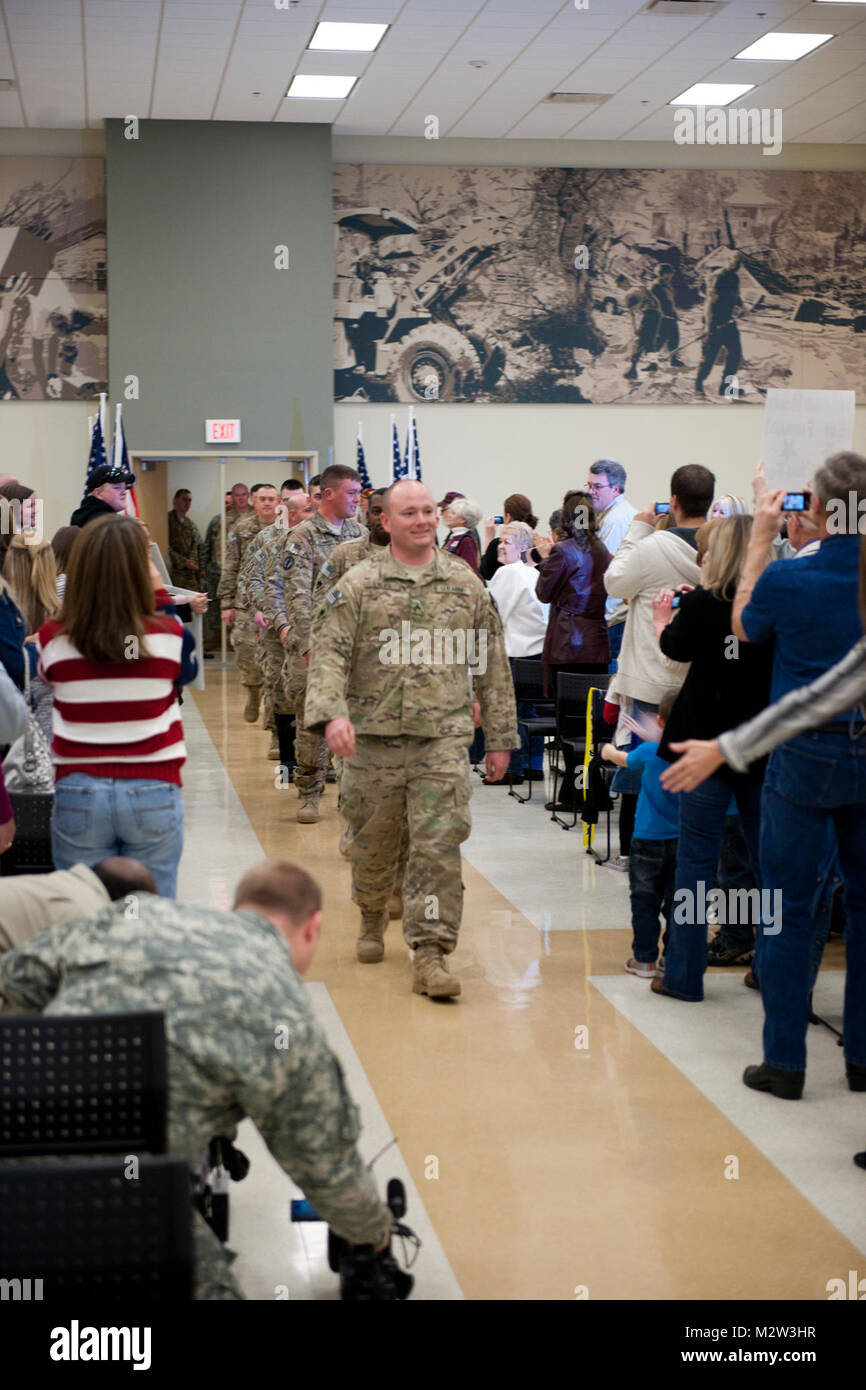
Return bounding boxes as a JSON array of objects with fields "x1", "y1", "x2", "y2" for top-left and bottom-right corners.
[{"x1": 106, "y1": 120, "x2": 334, "y2": 461}]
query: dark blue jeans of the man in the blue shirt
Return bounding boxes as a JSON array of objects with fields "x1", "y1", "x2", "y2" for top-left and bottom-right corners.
[{"x1": 758, "y1": 731, "x2": 866, "y2": 1072}]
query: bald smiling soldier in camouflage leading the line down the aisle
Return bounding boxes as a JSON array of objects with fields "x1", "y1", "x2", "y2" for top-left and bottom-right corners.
[{"x1": 306, "y1": 482, "x2": 520, "y2": 998}]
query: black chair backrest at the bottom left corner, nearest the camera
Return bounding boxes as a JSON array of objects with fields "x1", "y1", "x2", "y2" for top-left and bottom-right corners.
[{"x1": 0, "y1": 1156, "x2": 193, "y2": 1295}]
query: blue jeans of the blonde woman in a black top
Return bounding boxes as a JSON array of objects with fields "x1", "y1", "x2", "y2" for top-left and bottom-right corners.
[{"x1": 664, "y1": 773, "x2": 771, "y2": 1002}]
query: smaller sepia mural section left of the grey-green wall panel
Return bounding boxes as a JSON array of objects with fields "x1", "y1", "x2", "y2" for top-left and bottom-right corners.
[{"x1": 0, "y1": 156, "x2": 108, "y2": 400}]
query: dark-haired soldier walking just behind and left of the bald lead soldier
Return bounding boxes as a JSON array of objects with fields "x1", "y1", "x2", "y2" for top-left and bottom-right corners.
[{"x1": 264, "y1": 464, "x2": 364, "y2": 826}]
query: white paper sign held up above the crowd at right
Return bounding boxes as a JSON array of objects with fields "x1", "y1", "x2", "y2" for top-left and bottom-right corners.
[{"x1": 760, "y1": 388, "x2": 855, "y2": 492}]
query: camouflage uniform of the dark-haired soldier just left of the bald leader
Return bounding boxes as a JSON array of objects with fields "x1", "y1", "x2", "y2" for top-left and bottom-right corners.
[{"x1": 263, "y1": 513, "x2": 364, "y2": 798}]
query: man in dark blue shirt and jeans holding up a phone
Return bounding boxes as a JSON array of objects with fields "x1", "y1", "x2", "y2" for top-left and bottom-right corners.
[{"x1": 733, "y1": 452, "x2": 866, "y2": 1099}]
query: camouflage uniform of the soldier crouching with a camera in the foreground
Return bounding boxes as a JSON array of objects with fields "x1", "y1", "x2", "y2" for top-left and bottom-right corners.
[{"x1": 0, "y1": 894, "x2": 391, "y2": 1298}]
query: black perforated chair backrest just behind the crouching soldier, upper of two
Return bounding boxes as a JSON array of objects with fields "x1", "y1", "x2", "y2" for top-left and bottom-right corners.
[{"x1": 0, "y1": 1013, "x2": 167, "y2": 1158}]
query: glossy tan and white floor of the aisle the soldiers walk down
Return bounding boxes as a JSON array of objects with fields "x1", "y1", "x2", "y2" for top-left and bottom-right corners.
[{"x1": 181, "y1": 671, "x2": 866, "y2": 1300}]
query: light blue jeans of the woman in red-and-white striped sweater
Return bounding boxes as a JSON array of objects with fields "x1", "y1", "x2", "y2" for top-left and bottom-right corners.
[{"x1": 51, "y1": 773, "x2": 183, "y2": 898}]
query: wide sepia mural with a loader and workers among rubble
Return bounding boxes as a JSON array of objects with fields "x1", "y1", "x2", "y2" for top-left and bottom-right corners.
[{"x1": 334, "y1": 164, "x2": 866, "y2": 404}]
